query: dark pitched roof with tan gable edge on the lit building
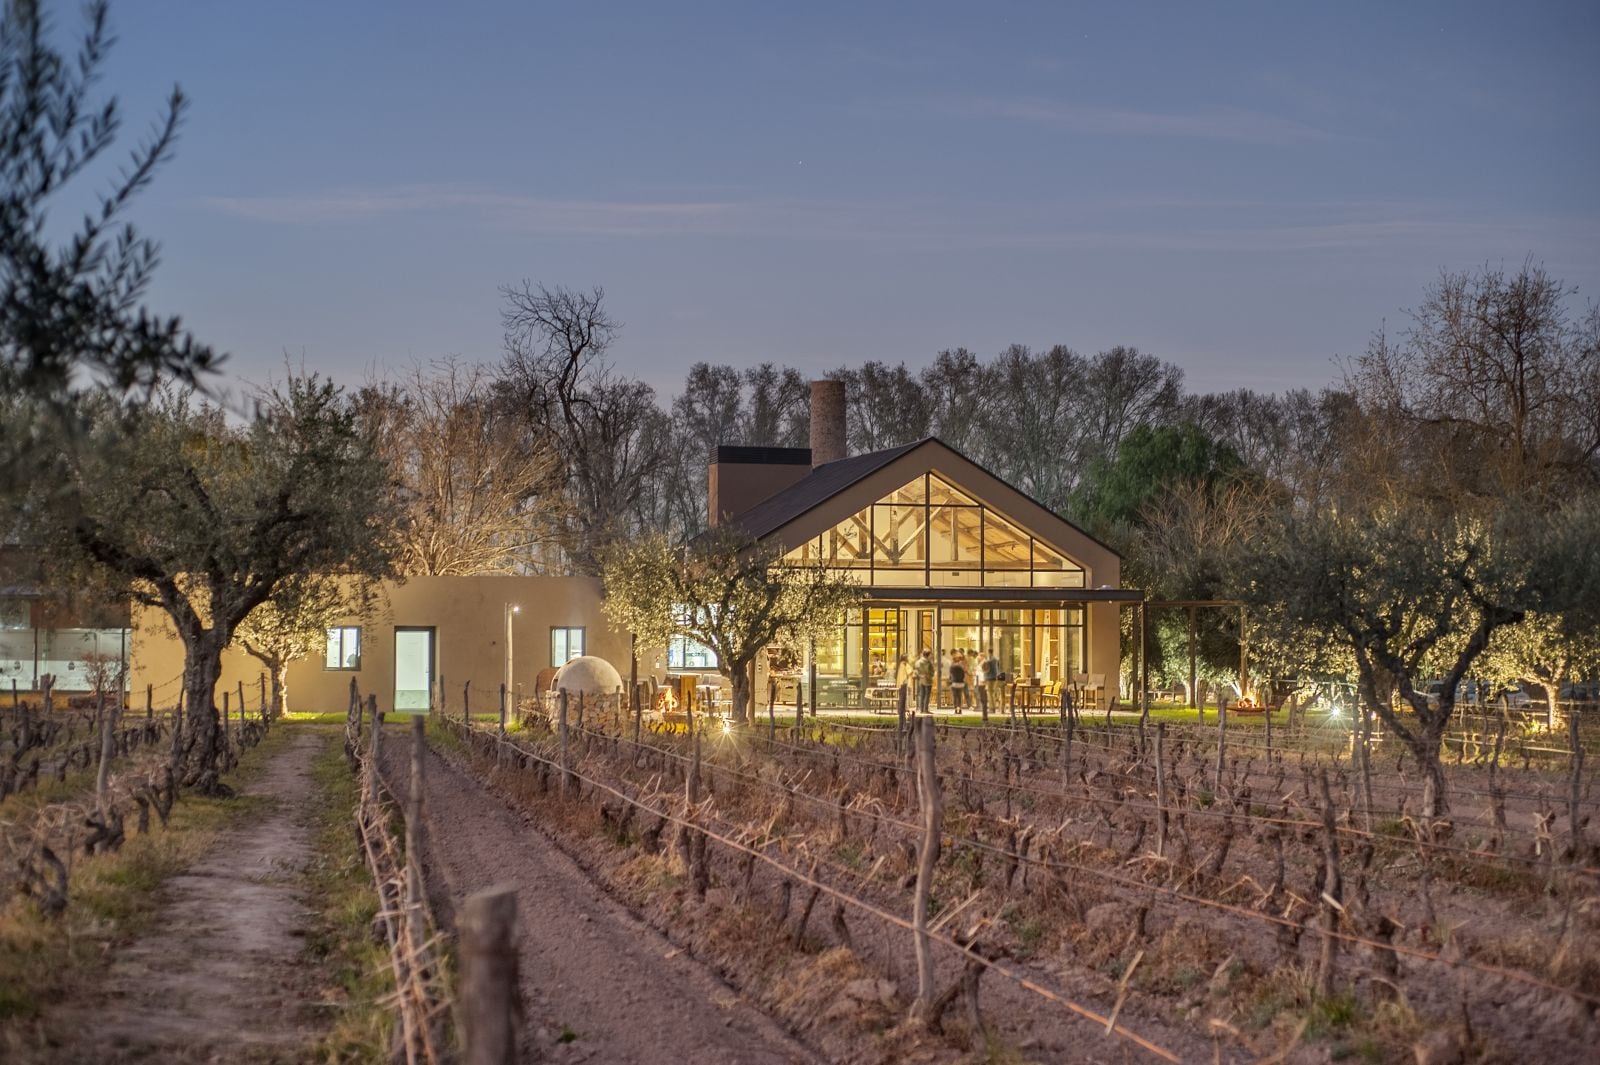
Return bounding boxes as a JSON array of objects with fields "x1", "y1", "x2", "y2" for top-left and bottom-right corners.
[{"x1": 728, "y1": 437, "x2": 1122, "y2": 568}]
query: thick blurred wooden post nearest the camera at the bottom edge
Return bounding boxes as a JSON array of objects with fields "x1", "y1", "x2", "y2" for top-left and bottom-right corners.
[{"x1": 461, "y1": 884, "x2": 522, "y2": 1065}]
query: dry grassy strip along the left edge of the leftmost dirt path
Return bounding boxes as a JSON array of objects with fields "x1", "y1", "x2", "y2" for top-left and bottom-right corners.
[{"x1": 0, "y1": 729, "x2": 286, "y2": 1036}]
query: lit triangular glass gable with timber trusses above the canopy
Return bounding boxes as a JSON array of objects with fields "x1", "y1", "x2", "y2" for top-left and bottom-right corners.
[{"x1": 787, "y1": 473, "x2": 1083, "y2": 588}]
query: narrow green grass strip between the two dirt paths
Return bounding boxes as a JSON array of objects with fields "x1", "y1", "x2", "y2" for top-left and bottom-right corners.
[{"x1": 306, "y1": 716, "x2": 406, "y2": 1065}]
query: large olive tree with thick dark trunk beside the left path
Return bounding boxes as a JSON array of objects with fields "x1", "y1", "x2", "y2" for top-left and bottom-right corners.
[{"x1": 40, "y1": 376, "x2": 394, "y2": 793}]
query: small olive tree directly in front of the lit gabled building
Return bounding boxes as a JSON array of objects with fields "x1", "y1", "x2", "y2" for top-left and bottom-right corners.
[{"x1": 602, "y1": 526, "x2": 861, "y2": 723}]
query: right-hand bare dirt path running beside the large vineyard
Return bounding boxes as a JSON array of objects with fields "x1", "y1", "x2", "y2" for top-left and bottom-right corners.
[{"x1": 387, "y1": 735, "x2": 818, "y2": 1065}]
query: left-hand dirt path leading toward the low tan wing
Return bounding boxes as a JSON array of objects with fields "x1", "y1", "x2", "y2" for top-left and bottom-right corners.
[{"x1": 50, "y1": 732, "x2": 328, "y2": 1062}]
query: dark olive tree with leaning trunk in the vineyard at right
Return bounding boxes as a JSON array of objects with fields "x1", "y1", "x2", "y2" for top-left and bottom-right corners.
[{"x1": 1242, "y1": 499, "x2": 1600, "y2": 817}]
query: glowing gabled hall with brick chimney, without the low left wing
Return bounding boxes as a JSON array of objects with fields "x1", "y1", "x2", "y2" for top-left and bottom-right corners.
[{"x1": 709, "y1": 381, "x2": 1142, "y2": 707}]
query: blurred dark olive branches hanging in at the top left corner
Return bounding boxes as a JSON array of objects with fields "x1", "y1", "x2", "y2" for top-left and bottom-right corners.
[{"x1": 0, "y1": 0, "x2": 219, "y2": 494}]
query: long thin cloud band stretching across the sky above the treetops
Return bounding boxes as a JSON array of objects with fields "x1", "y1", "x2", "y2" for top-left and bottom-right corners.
[{"x1": 196, "y1": 180, "x2": 1600, "y2": 254}]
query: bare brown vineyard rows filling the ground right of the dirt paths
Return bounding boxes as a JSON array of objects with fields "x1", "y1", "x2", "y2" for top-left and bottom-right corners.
[{"x1": 419, "y1": 700, "x2": 1600, "y2": 1062}]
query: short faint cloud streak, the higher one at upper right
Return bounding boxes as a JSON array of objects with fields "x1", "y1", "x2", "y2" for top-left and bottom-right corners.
[{"x1": 941, "y1": 96, "x2": 1334, "y2": 146}]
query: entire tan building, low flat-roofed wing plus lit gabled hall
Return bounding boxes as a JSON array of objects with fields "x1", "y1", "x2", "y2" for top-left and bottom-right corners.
[{"x1": 131, "y1": 381, "x2": 1142, "y2": 712}]
